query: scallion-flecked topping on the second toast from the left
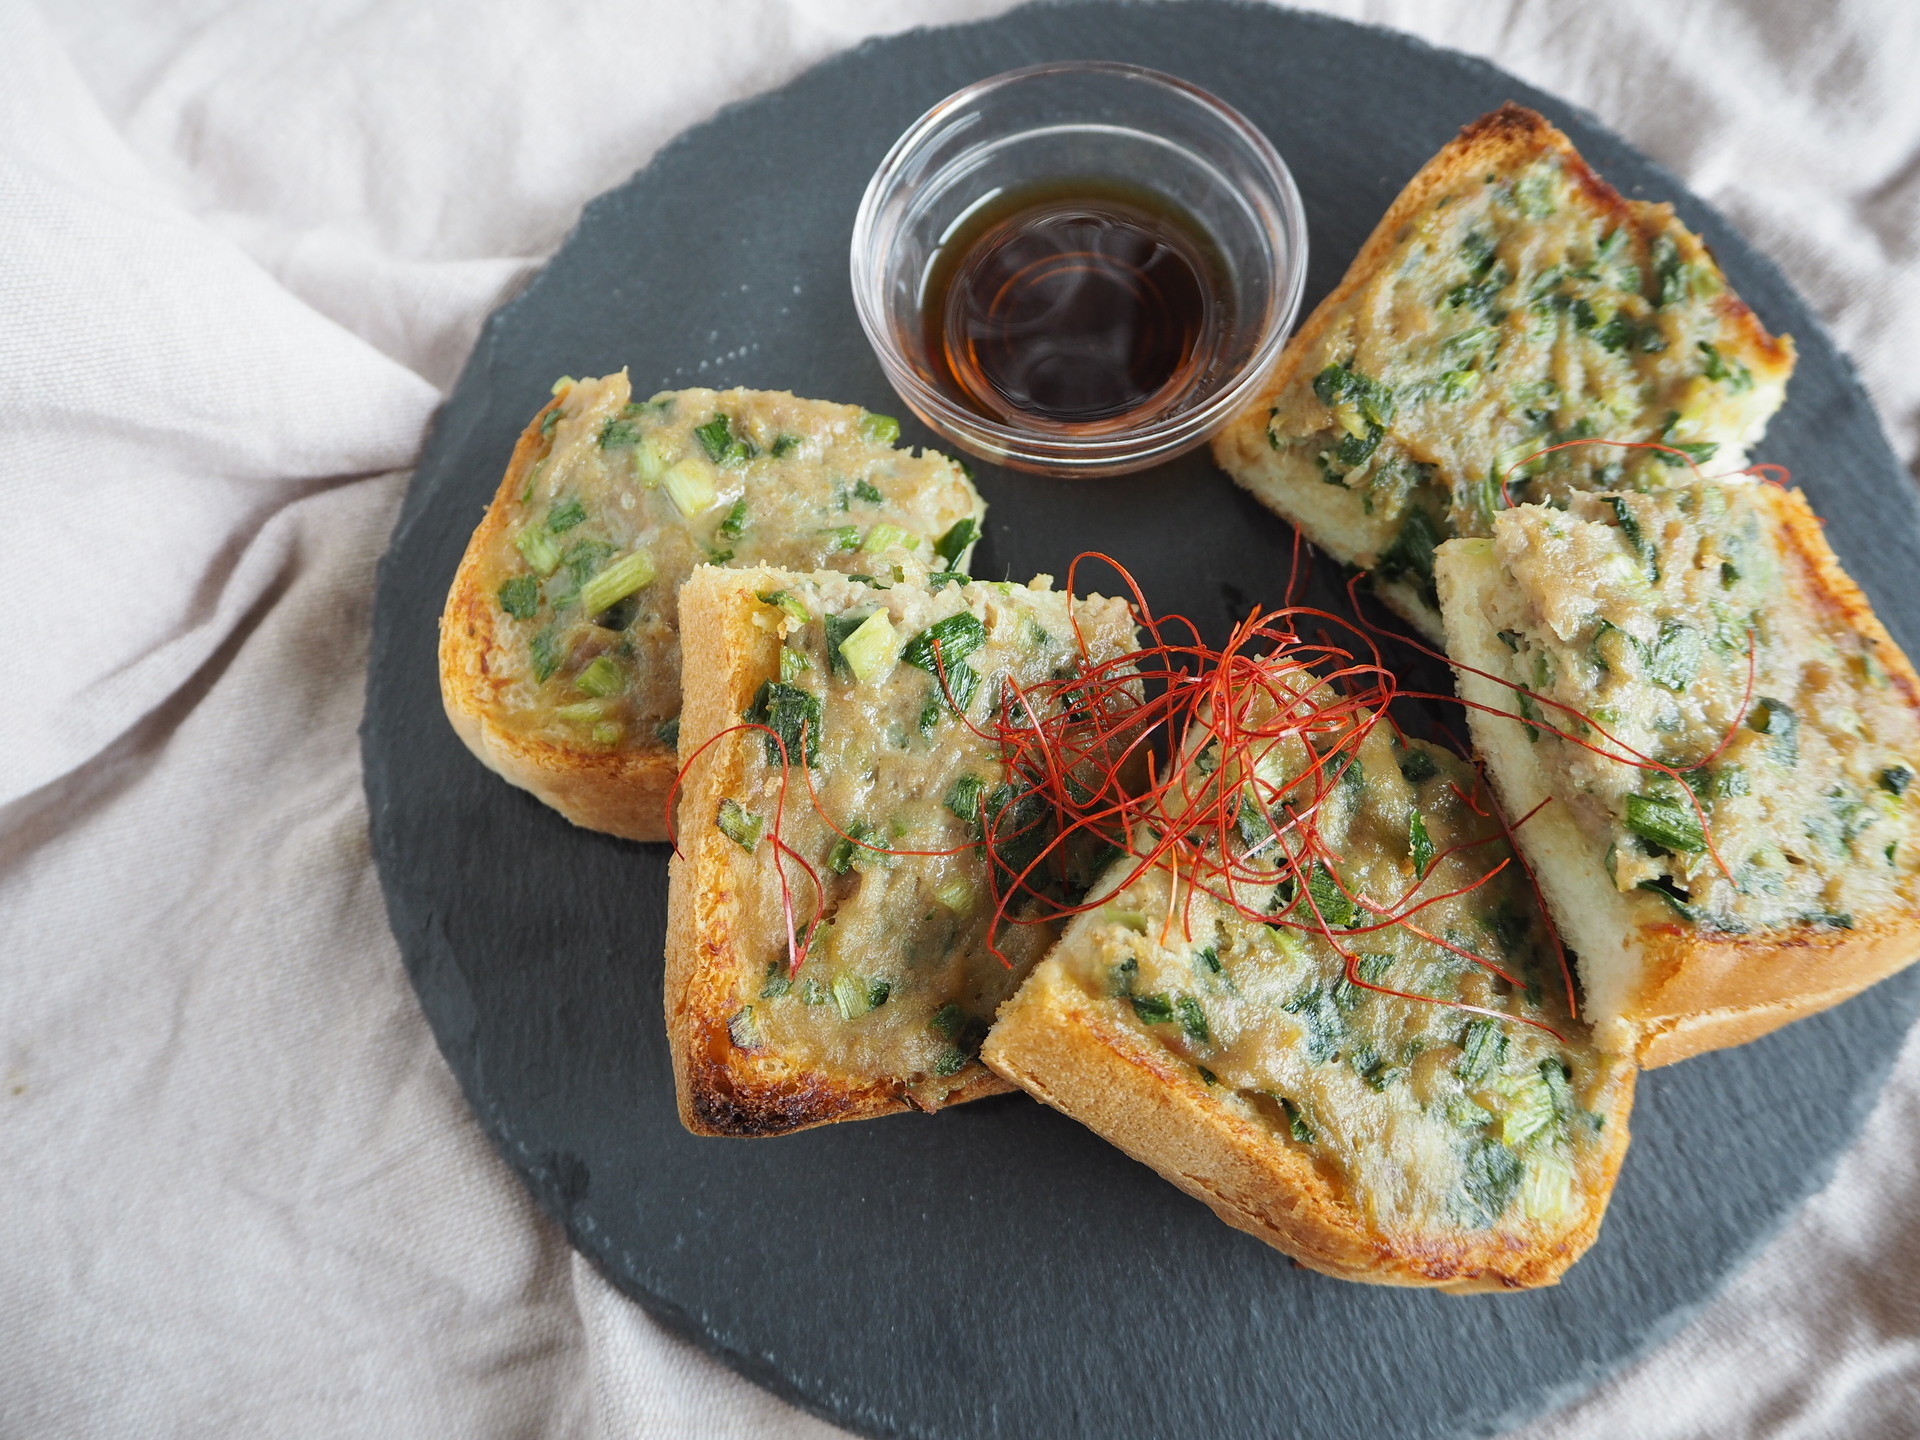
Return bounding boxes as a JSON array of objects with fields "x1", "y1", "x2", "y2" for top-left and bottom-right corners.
[{"x1": 682, "y1": 570, "x2": 1128, "y2": 1108}]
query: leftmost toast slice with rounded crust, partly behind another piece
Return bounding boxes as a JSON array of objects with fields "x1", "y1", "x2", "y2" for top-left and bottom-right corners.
[{"x1": 440, "y1": 371, "x2": 985, "y2": 841}]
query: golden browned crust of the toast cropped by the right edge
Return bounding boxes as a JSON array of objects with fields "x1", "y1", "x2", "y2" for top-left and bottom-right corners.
[{"x1": 1440, "y1": 486, "x2": 1920, "y2": 1069}]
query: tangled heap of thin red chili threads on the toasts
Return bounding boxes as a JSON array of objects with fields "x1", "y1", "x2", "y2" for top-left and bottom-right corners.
[{"x1": 668, "y1": 552, "x2": 1576, "y2": 1035}]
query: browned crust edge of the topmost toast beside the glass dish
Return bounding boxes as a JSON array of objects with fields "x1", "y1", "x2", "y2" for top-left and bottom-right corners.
[{"x1": 1213, "y1": 102, "x2": 1793, "y2": 641}]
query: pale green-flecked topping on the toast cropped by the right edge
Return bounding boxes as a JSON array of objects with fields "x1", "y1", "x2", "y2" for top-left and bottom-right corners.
[{"x1": 1466, "y1": 482, "x2": 1920, "y2": 933}]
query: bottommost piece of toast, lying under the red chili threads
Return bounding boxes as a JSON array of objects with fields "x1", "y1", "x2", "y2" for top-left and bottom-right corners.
[{"x1": 983, "y1": 724, "x2": 1634, "y2": 1292}]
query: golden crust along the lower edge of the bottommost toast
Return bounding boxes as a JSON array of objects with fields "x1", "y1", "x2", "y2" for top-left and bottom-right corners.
[{"x1": 981, "y1": 952, "x2": 1634, "y2": 1294}]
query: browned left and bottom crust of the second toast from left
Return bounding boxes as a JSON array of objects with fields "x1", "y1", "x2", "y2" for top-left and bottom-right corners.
[{"x1": 666, "y1": 566, "x2": 1012, "y2": 1137}]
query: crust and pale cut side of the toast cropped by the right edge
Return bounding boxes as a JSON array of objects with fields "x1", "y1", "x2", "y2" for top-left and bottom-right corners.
[{"x1": 1436, "y1": 486, "x2": 1920, "y2": 1069}]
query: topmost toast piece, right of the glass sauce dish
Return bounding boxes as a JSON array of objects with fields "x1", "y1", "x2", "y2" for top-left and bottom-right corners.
[{"x1": 1213, "y1": 106, "x2": 1793, "y2": 641}]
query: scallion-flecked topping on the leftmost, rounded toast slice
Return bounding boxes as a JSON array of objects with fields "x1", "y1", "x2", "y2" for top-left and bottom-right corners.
[{"x1": 464, "y1": 372, "x2": 981, "y2": 749}]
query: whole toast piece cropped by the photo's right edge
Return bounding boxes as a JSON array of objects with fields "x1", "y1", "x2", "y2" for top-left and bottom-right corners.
[{"x1": 1438, "y1": 482, "x2": 1920, "y2": 1066}]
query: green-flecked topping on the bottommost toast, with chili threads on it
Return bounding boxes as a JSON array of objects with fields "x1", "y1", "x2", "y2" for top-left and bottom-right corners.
[{"x1": 1006, "y1": 599, "x2": 1632, "y2": 1251}]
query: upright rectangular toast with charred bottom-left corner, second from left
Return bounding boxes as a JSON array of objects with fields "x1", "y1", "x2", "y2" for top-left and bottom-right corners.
[{"x1": 666, "y1": 566, "x2": 1135, "y2": 1135}]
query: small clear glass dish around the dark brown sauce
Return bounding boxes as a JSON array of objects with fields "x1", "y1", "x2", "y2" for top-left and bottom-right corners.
[{"x1": 852, "y1": 61, "x2": 1308, "y2": 476}]
